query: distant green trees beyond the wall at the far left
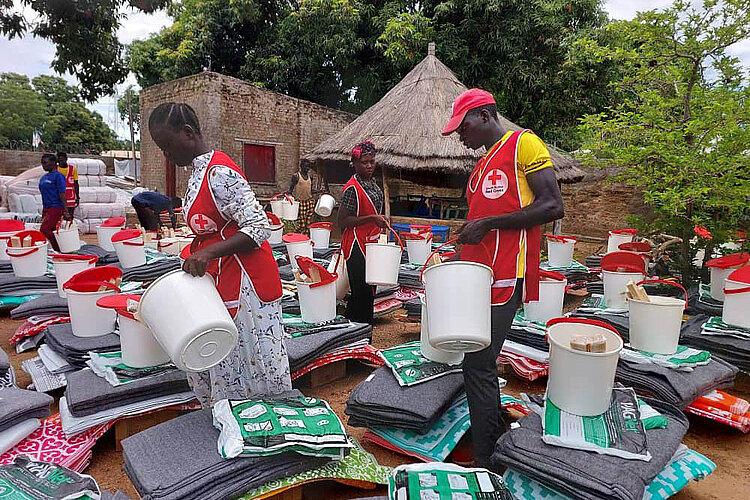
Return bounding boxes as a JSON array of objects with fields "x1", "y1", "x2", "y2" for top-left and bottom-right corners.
[{"x1": 0, "y1": 73, "x2": 115, "y2": 152}]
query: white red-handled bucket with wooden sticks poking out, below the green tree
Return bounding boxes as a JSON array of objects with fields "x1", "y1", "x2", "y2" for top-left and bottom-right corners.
[{"x1": 628, "y1": 280, "x2": 687, "y2": 354}]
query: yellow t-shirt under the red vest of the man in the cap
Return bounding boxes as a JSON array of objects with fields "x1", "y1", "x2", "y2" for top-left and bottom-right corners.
[{"x1": 485, "y1": 130, "x2": 552, "y2": 278}]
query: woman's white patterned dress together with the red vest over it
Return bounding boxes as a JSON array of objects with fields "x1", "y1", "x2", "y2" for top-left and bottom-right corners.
[{"x1": 183, "y1": 151, "x2": 292, "y2": 407}]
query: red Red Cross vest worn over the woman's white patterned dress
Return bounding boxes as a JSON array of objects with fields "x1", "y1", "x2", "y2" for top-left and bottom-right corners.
[{"x1": 182, "y1": 151, "x2": 281, "y2": 316}]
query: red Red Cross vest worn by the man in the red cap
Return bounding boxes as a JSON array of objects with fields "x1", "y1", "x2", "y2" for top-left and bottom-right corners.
[{"x1": 461, "y1": 130, "x2": 542, "y2": 305}]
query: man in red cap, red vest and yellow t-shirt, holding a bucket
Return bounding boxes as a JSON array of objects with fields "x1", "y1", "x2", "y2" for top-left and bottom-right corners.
[{"x1": 443, "y1": 89, "x2": 563, "y2": 468}]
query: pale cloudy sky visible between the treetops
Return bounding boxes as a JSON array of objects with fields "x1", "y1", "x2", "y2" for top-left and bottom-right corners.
[{"x1": 0, "y1": 0, "x2": 750, "y2": 139}]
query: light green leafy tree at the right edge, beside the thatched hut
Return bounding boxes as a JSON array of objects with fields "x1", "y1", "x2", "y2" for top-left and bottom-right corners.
[{"x1": 577, "y1": 0, "x2": 750, "y2": 284}]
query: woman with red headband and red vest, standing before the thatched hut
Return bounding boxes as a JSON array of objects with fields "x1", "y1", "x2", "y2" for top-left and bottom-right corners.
[{"x1": 338, "y1": 141, "x2": 388, "y2": 324}]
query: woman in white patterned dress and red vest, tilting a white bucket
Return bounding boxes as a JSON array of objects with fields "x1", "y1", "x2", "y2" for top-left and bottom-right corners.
[{"x1": 148, "y1": 103, "x2": 292, "y2": 407}]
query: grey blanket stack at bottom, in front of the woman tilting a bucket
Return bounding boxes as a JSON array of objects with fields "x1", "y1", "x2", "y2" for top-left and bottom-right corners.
[{"x1": 122, "y1": 402, "x2": 328, "y2": 500}]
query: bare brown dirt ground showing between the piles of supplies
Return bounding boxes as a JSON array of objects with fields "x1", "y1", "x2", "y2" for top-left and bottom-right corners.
[{"x1": 0, "y1": 238, "x2": 750, "y2": 500}]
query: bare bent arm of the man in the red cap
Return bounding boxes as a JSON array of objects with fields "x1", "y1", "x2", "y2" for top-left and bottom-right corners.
[{"x1": 458, "y1": 167, "x2": 565, "y2": 245}]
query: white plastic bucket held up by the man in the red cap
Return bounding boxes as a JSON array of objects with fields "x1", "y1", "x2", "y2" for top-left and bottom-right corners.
[{"x1": 426, "y1": 260, "x2": 493, "y2": 352}]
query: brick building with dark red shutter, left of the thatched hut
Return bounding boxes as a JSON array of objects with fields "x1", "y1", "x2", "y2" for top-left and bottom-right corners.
[{"x1": 140, "y1": 72, "x2": 355, "y2": 197}]
